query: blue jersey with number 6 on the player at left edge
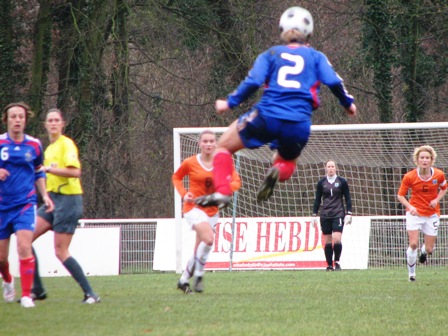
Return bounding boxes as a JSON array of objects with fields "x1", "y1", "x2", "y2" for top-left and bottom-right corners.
[{"x1": 0, "y1": 133, "x2": 45, "y2": 210}]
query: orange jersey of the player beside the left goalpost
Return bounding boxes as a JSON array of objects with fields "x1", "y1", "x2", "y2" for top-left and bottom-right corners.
[{"x1": 172, "y1": 154, "x2": 241, "y2": 216}]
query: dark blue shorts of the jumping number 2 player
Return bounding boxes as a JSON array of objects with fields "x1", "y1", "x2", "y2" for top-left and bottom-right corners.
[{"x1": 237, "y1": 108, "x2": 311, "y2": 160}]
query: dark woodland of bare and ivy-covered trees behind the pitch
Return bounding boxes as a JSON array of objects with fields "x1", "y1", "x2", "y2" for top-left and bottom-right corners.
[{"x1": 0, "y1": 0, "x2": 448, "y2": 218}]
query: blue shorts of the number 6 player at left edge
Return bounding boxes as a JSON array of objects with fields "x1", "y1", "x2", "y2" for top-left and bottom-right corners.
[{"x1": 0, "y1": 204, "x2": 36, "y2": 239}]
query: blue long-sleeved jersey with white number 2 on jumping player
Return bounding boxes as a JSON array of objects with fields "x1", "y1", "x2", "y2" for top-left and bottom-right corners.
[{"x1": 227, "y1": 45, "x2": 353, "y2": 121}]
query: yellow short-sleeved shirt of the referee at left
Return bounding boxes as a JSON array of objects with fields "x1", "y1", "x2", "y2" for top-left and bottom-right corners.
[{"x1": 44, "y1": 135, "x2": 82, "y2": 195}]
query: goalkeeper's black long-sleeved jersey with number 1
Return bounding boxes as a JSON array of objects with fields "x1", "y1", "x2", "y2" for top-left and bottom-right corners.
[{"x1": 313, "y1": 176, "x2": 352, "y2": 218}]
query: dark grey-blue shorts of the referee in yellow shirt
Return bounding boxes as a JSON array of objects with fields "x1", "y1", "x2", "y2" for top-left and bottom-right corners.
[{"x1": 37, "y1": 192, "x2": 82, "y2": 234}]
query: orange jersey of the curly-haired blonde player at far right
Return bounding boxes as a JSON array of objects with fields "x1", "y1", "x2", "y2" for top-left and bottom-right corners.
[{"x1": 398, "y1": 168, "x2": 447, "y2": 217}]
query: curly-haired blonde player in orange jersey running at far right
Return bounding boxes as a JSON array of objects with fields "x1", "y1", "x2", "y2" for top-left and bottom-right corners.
[{"x1": 397, "y1": 146, "x2": 447, "y2": 281}]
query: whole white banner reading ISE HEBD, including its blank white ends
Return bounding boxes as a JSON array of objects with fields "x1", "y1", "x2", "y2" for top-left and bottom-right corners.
[{"x1": 154, "y1": 217, "x2": 370, "y2": 271}]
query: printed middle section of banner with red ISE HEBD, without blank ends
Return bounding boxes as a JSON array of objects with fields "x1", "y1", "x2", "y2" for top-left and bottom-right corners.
[{"x1": 210, "y1": 218, "x2": 326, "y2": 269}]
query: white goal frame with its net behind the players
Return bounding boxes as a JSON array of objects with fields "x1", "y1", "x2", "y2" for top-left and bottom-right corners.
[{"x1": 173, "y1": 122, "x2": 448, "y2": 272}]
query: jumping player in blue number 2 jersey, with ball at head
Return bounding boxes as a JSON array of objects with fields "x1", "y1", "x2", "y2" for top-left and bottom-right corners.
[{"x1": 195, "y1": 7, "x2": 356, "y2": 207}]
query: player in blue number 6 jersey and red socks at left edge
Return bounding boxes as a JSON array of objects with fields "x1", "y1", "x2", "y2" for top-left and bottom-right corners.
[{"x1": 0, "y1": 103, "x2": 54, "y2": 308}]
